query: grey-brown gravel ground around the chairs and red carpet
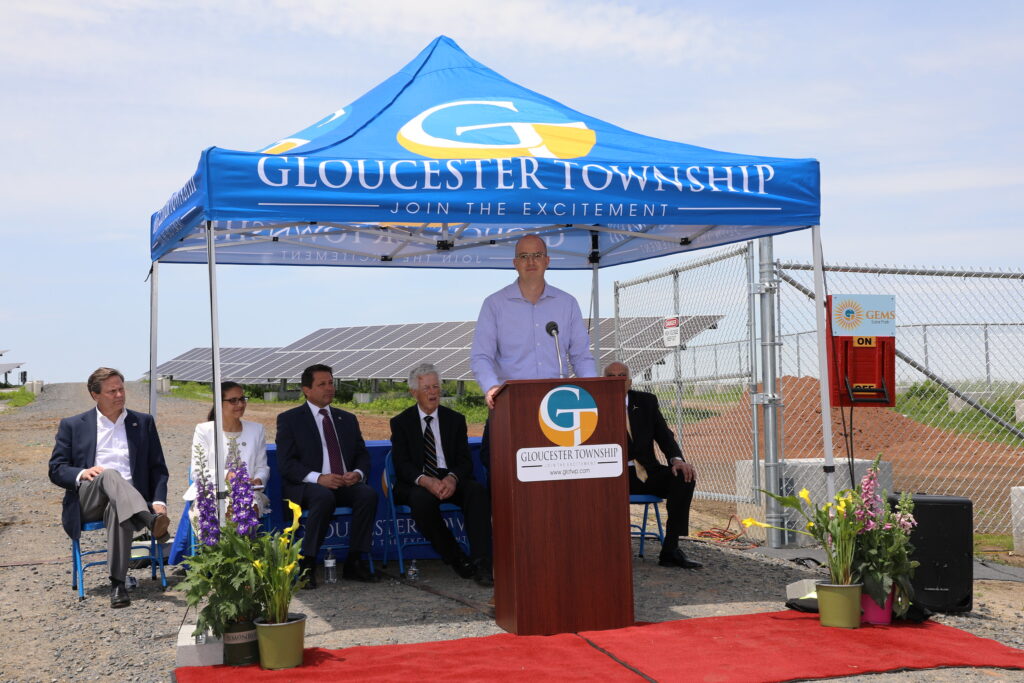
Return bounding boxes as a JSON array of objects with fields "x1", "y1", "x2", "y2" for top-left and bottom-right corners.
[{"x1": 0, "y1": 383, "x2": 1024, "y2": 681}]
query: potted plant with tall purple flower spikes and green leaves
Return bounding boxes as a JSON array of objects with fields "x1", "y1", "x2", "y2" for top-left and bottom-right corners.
[{"x1": 181, "y1": 445, "x2": 262, "y2": 666}]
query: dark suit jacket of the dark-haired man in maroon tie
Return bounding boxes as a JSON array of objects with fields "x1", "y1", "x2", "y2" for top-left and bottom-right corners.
[{"x1": 275, "y1": 402, "x2": 370, "y2": 501}]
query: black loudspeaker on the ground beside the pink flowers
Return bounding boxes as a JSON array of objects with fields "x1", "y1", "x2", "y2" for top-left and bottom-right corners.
[{"x1": 889, "y1": 494, "x2": 974, "y2": 612}]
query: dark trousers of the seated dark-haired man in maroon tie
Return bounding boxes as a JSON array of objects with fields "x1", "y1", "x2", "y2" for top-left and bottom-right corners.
[{"x1": 297, "y1": 481, "x2": 377, "y2": 561}]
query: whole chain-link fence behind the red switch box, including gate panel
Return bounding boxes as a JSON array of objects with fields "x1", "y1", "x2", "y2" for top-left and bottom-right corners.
[{"x1": 615, "y1": 243, "x2": 1024, "y2": 543}]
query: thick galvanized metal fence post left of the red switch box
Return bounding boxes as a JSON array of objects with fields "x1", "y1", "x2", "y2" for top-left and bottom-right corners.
[{"x1": 755, "y1": 238, "x2": 785, "y2": 548}]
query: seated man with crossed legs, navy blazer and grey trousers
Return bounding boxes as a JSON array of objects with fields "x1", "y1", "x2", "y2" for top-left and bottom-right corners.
[{"x1": 49, "y1": 368, "x2": 170, "y2": 607}]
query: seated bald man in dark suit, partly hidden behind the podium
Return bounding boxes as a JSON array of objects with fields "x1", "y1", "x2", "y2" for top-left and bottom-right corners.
[{"x1": 604, "y1": 362, "x2": 703, "y2": 569}]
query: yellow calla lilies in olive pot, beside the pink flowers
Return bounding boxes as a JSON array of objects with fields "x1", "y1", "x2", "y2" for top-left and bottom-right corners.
[{"x1": 742, "y1": 488, "x2": 863, "y2": 629}]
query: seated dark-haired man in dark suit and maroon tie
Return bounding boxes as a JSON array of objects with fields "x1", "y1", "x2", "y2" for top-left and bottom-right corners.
[{"x1": 276, "y1": 365, "x2": 380, "y2": 588}]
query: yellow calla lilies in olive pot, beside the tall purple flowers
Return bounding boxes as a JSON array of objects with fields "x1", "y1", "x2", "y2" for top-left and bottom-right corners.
[{"x1": 252, "y1": 501, "x2": 306, "y2": 669}]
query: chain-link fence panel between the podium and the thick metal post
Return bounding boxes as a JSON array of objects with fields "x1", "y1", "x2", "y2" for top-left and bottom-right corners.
[{"x1": 615, "y1": 244, "x2": 759, "y2": 501}]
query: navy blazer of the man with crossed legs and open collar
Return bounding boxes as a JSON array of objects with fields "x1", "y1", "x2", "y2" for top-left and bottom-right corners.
[{"x1": 49, "y1": 408, "x2": 167, "y2": 539}]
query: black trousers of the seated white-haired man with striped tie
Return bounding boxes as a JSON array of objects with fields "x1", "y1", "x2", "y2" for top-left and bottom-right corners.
[{"x1": 394, "y1": 479, "x2": 490, "y2": 564}]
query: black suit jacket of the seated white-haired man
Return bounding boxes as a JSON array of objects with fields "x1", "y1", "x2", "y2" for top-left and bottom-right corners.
[{"x1": 391, "y1": 405, "x2": 473, "y2": 486}]
